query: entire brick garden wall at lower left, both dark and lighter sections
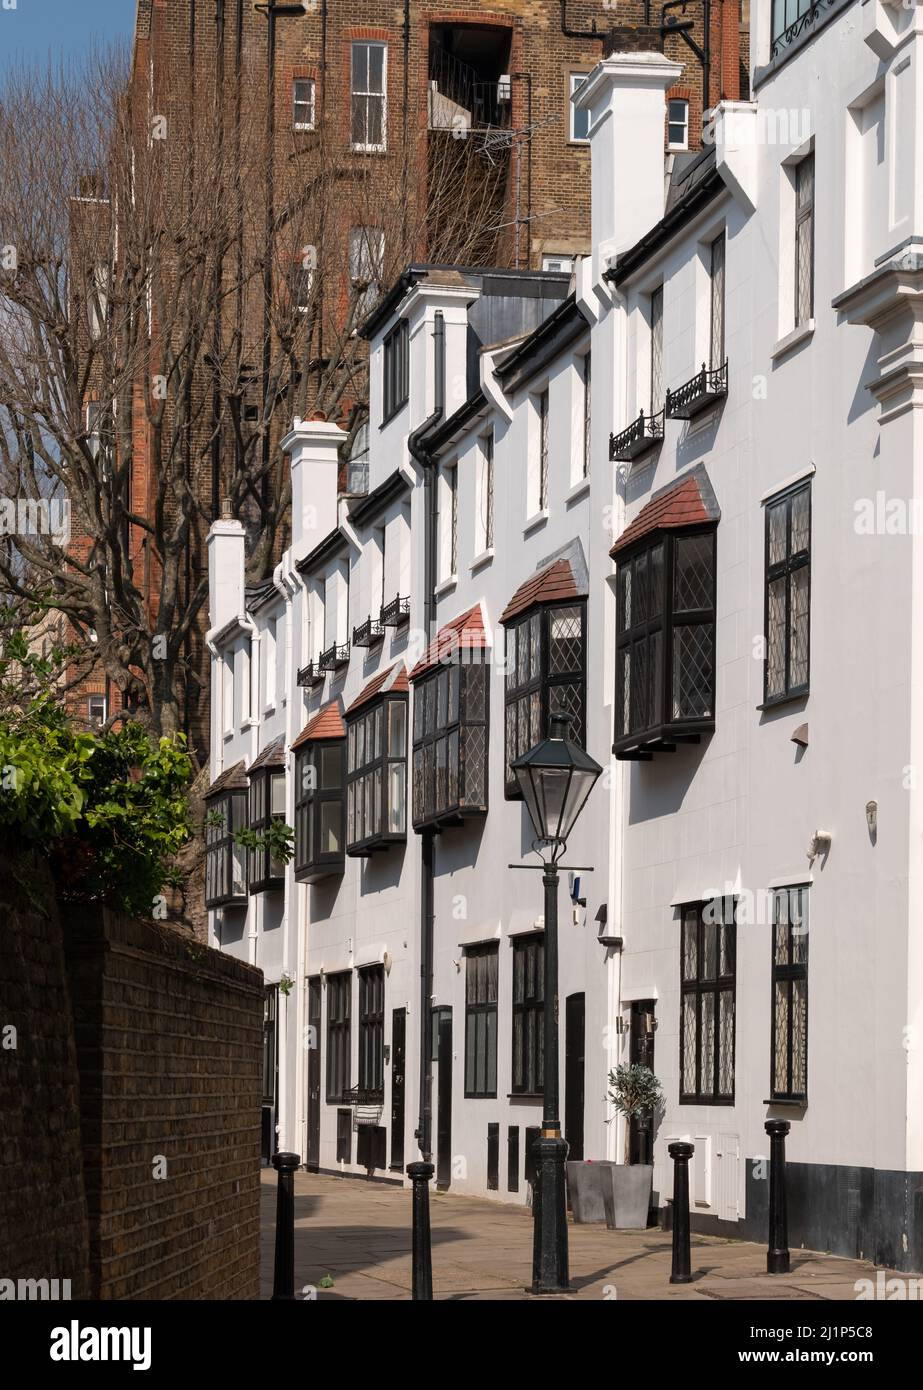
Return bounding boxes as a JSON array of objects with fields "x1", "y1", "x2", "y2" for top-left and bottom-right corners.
[{"x1": 0, "y1": 856, "x2": 263, "y2": 1300}]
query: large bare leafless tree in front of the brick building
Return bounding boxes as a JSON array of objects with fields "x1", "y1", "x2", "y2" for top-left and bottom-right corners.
[{"x1": 0, "y1": 53, "x2": 506, "y2": 750}]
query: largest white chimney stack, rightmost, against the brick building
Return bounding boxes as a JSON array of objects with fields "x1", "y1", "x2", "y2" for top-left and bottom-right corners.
[{"x1": 574, "y1": 53, "x2": 683, "y2": 273}]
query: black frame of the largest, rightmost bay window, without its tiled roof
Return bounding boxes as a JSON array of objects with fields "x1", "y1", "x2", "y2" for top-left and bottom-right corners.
[{"x1": 613, "y1": 521, "x2": 717, "y2": 756}]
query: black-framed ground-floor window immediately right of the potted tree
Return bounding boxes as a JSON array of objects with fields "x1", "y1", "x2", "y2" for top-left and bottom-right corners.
[{"x1": 678, "y1": 897, "x2": 737, "y2": 1105}]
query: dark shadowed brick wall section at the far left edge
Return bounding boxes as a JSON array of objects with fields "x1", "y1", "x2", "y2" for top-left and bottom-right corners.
[{"x1": 0, "y1": 855, "x2": 90, "y2": 1298}]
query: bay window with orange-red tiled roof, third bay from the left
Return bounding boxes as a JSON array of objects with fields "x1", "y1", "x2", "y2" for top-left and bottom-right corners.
[{"x1": 292, "y1": 703, "x2": 346, "y2": 883}]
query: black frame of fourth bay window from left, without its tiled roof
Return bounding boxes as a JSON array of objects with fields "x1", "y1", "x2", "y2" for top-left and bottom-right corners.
[{"x1": 346, "y1": 692, "x2": 410, "y2": 859}]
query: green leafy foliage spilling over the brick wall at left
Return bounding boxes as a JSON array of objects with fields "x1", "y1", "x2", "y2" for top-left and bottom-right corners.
[{"x1": 0, "y1": 641, "x2": 192, "y2": 916}]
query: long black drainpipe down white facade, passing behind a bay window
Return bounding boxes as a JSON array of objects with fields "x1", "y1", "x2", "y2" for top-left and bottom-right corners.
[{"x1": 407, "y1": 310, "x2": 445, "y2": 1162}]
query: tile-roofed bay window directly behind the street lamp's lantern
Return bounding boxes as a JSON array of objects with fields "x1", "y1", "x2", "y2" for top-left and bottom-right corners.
[{"x1": 500, "y1": 560, "x2": 587, "y2": 801}]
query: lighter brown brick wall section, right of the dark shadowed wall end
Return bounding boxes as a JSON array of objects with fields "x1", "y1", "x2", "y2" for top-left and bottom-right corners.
[{"x1": 65, "y1": 910, "x2": 263, "y2": 1300}]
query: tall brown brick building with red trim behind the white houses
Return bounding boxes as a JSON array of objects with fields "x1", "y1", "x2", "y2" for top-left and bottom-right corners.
[{"x1": 82, "y1": 0, "x2": 745, "y2": 753}]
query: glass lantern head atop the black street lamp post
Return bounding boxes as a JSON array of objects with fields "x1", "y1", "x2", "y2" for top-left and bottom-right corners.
[{"x1": 513, "y1": 714, "x2": 602, "y2": 844}]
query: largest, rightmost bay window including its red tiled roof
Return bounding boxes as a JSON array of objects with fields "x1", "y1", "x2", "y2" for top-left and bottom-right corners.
[{"x1": 612, "y1": 466, "x2": 720, "y2": 760}]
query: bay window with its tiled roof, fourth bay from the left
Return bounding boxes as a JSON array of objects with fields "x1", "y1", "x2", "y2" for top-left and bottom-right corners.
[{"x1": 346, "y1": 666, "x2": 407, "y2": 858}]
